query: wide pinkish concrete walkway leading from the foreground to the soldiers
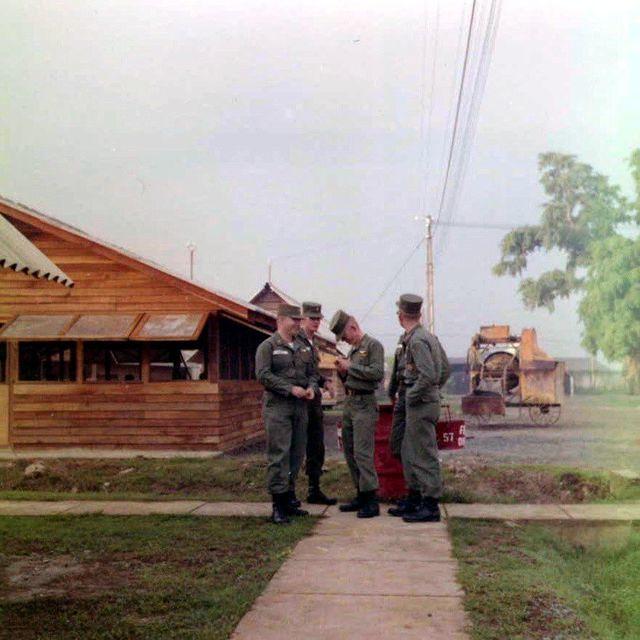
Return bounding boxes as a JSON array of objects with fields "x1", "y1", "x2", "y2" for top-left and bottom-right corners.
[{"x1": 232, "y1": 507, "x2": 468, "y2": 640}]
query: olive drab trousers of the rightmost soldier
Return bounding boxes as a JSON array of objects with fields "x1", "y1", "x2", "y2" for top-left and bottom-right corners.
[{"x1": 402, "y1": 402, "x2": 442, "y2": 498}]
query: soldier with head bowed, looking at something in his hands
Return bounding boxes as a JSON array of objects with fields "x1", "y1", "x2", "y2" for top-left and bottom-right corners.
[{"x1": 330, "y1": 310, "x2": 384, "y2": 518}]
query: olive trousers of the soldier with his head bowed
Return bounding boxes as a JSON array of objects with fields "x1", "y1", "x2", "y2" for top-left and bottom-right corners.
[{"x1": 342, "y1": 394, "x2": 378, "y2": 491}]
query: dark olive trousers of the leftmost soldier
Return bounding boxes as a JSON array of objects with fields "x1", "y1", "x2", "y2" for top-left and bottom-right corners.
[{"x1": 262, "y1": 394, "x2": 308, "y2": 495}]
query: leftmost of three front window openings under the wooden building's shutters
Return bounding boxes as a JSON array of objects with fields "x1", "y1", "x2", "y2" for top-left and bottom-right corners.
[{"x1": 18, "y1": 342, "x2": 76, "y2": 382}]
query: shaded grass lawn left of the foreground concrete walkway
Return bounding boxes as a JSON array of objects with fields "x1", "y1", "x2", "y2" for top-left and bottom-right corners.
[{"x1": 0, "y1": 516, "x2": 315, "y2": 640}]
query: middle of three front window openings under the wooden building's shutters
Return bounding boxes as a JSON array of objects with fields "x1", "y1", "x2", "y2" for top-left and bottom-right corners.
[{"x1": 83, "y1": 342, "x2": 142, "y2": 382}]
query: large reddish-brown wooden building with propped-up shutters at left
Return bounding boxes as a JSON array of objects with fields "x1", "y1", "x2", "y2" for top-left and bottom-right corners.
[{"x1": 0, "y1": 199, "x2": 275, "y2": 451}]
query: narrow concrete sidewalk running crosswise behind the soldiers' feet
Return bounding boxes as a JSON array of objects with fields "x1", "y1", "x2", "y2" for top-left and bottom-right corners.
[{"x1": 0, "y1": 500, "x2": 640, "y2": 521}]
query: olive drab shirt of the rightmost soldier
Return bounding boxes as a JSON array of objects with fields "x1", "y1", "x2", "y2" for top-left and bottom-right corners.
[{"x1": 404, "y1": 324, "x2": 451, "y2": 405}]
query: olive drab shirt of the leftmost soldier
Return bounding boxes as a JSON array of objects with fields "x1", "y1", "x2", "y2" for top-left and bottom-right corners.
[{"x1": 256, "y1": 331, "x2": 319, "y2": 397}]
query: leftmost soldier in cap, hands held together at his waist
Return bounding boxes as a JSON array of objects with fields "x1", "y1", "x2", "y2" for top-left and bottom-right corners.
[{"x1": 256, "y1": 304, "x2": 320, "y2": 524}]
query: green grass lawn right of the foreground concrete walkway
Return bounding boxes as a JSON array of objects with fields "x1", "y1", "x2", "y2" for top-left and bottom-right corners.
[{"x1": 449, "y1": 519, "x2": 640, "y2": 640}]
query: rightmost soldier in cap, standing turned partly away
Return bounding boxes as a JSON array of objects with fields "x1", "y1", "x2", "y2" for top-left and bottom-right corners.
[{"x1": 389, "y1": 293, "x2": 450, "y2": 522}]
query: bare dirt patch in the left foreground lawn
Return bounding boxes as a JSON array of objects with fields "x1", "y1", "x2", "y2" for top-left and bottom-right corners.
[{"x1": 0, "y1": 555, "x2": 139, "y2": 602}]
